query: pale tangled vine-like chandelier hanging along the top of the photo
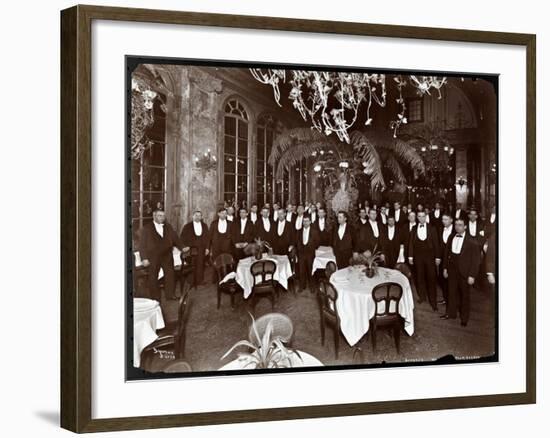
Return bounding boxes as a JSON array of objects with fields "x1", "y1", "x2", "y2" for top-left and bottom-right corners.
[{"x1": 250, "y1": 68, "x2": 447, "y2": 143}]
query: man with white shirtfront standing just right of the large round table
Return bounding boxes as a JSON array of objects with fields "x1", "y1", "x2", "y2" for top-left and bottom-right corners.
[{"x1": 408, "y1": 210, "x2": 441, "y2": 311}]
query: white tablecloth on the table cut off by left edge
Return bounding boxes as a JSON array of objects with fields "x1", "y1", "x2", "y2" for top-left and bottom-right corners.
[{"x1": 134, "y1": 298, "x2": 164, "y2": 367}]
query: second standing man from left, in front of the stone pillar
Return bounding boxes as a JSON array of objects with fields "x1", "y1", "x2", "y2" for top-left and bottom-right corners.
[{"x1": 180, "y1": 210, "x2": 210, "y2": 287}]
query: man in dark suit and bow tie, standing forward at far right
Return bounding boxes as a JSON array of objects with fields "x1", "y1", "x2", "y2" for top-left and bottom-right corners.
[{"x1": 442, "y1": 219, "x2": 480, "y2": 326}]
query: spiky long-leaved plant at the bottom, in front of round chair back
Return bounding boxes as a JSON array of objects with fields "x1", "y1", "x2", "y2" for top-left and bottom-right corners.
[{"x1": 221, "y1": 313, "x2": 301, "y2": 369}]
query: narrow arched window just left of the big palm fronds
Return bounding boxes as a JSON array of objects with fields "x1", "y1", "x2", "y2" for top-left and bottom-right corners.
[{"x1": 256, "y1": 116, "x2": 275, "y2": 206}]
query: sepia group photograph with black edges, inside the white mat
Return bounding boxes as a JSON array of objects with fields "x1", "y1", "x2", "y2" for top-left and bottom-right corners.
[{"x1": 128, "y1": 56, "x2": 499, "y2": 380}]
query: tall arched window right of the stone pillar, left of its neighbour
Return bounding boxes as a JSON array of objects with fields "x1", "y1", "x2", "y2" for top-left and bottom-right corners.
[{"x1": 223, "y1": 99, "x2": 248, "y2": 205}]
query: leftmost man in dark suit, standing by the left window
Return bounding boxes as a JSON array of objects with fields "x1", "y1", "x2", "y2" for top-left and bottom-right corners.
[{"x1": 139, "y1": 209, "x2": 181, "y2": 302}]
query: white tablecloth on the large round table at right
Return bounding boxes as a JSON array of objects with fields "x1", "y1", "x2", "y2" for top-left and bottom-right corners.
[{"x1": 330, "y1": 266, "x2": 414, "y2": 346}]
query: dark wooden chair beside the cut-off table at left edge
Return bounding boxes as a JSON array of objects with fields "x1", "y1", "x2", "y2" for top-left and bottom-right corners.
[{"x1": 140, "y1": 293, "x2": 190, "y2": 373}]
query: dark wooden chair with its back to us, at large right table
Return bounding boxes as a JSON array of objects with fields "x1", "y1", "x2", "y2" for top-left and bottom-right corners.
[{"x1": 369, "y1": 282, "x2": 404, "y2": 353}]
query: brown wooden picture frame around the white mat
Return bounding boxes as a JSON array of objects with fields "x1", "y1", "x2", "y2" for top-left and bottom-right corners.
[{"x1": 61, "y1": 5, "x2": 536, "y2": 432}]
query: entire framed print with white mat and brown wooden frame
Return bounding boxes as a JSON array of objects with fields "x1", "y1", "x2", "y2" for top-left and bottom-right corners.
[{"x1": 61, "y1": 6, "x2": 536, "y2": 432}]
